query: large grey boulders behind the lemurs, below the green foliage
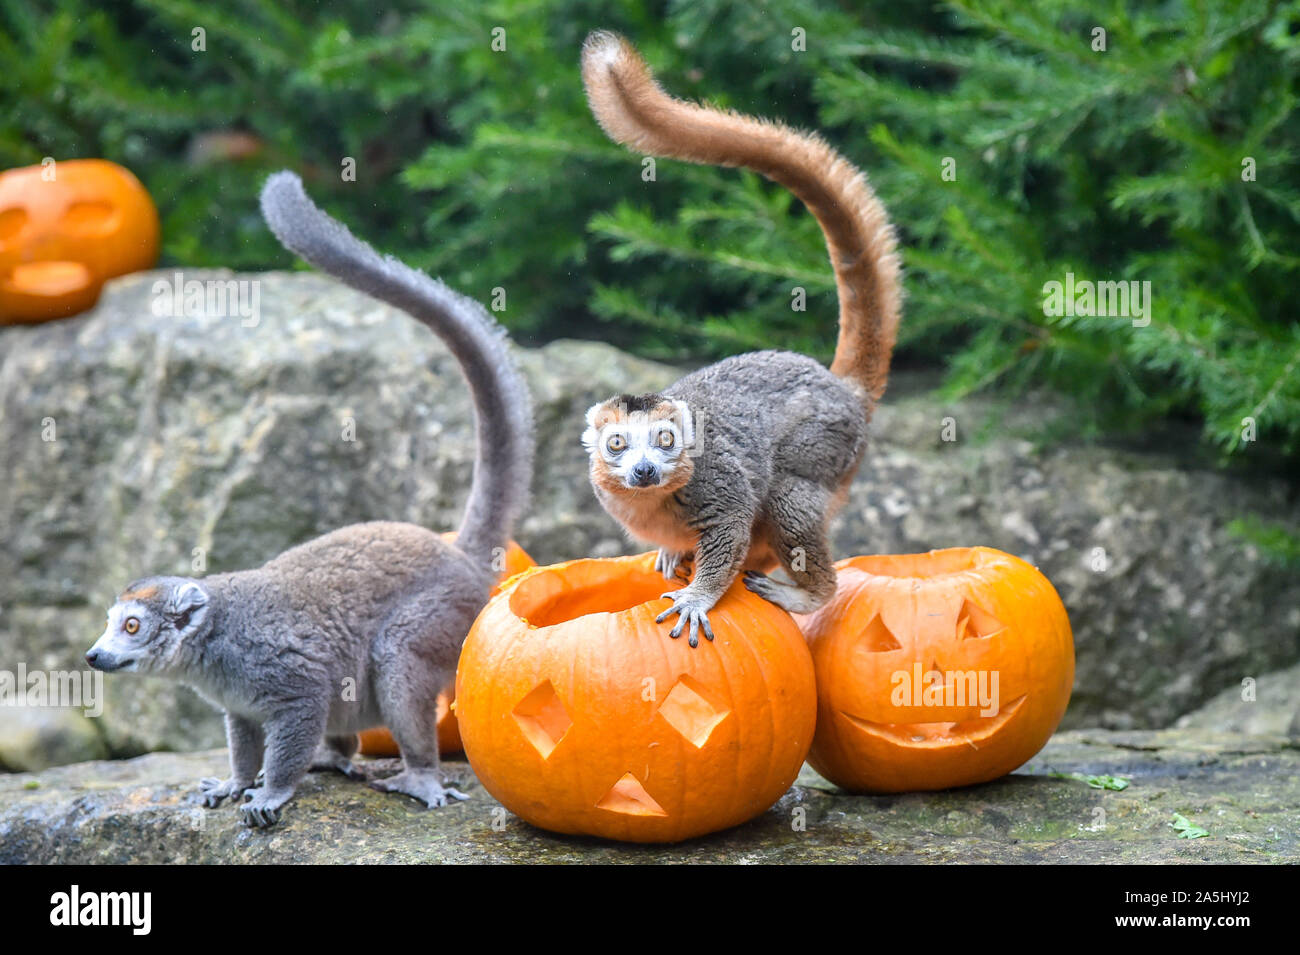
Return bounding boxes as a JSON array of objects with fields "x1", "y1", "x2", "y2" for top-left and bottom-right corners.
[{"x1": 0, "y1": 272, "x2": 1300, "y2": 769}]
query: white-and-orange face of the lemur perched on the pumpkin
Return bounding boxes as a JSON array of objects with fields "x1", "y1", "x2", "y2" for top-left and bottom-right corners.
[{"x1": 582, "y1": 395, "x2": 696, "y2": 494}]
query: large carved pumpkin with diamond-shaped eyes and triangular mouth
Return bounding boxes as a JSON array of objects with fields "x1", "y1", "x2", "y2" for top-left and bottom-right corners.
[{"x1": 456, "y1": 554, "x2": 816, "y2": 842}]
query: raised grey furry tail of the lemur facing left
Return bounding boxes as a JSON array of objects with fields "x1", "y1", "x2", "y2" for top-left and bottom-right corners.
[{"x1": 261, "y1": 172, "x2": 534, "y2": 564}]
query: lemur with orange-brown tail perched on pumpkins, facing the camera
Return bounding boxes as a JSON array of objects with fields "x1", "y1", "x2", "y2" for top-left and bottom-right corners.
[{"x1": 582, "y1": 32, "x2": 901, "y2": 647}]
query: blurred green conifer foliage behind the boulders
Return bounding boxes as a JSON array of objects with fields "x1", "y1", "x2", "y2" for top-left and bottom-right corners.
[{"x1": 0, "y1": 0, "x2": 1300, "y2": 548}]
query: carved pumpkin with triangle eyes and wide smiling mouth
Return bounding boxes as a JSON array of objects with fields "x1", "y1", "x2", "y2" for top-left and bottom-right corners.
[{"x1": 800, "y1": 547, "x2": 1074, "y2": 793}]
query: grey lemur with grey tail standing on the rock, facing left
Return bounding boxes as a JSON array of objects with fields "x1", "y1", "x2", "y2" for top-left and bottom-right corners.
[{"x1": 86, "y1": 173, "x2": 533, "y2": 826}]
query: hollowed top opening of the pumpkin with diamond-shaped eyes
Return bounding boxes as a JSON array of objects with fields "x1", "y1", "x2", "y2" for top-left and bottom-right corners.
[{"x1": 510, "y1": 560, "x2": 672, "y2": 628}]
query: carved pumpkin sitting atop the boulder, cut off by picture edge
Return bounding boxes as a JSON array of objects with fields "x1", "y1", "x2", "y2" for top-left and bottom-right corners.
[{"x1": 0, "y1": 160, "x2": 159, "y2": 325}]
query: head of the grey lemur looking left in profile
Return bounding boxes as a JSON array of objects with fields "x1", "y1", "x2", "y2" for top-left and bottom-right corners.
[{"x1": 86, "y1": 577, "x2": 208, "y2": 673}]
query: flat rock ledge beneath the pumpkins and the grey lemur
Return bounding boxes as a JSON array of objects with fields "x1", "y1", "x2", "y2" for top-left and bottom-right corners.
[{"x1": 0, "y1": 730, "x2": 1300, "y2": 863}]
